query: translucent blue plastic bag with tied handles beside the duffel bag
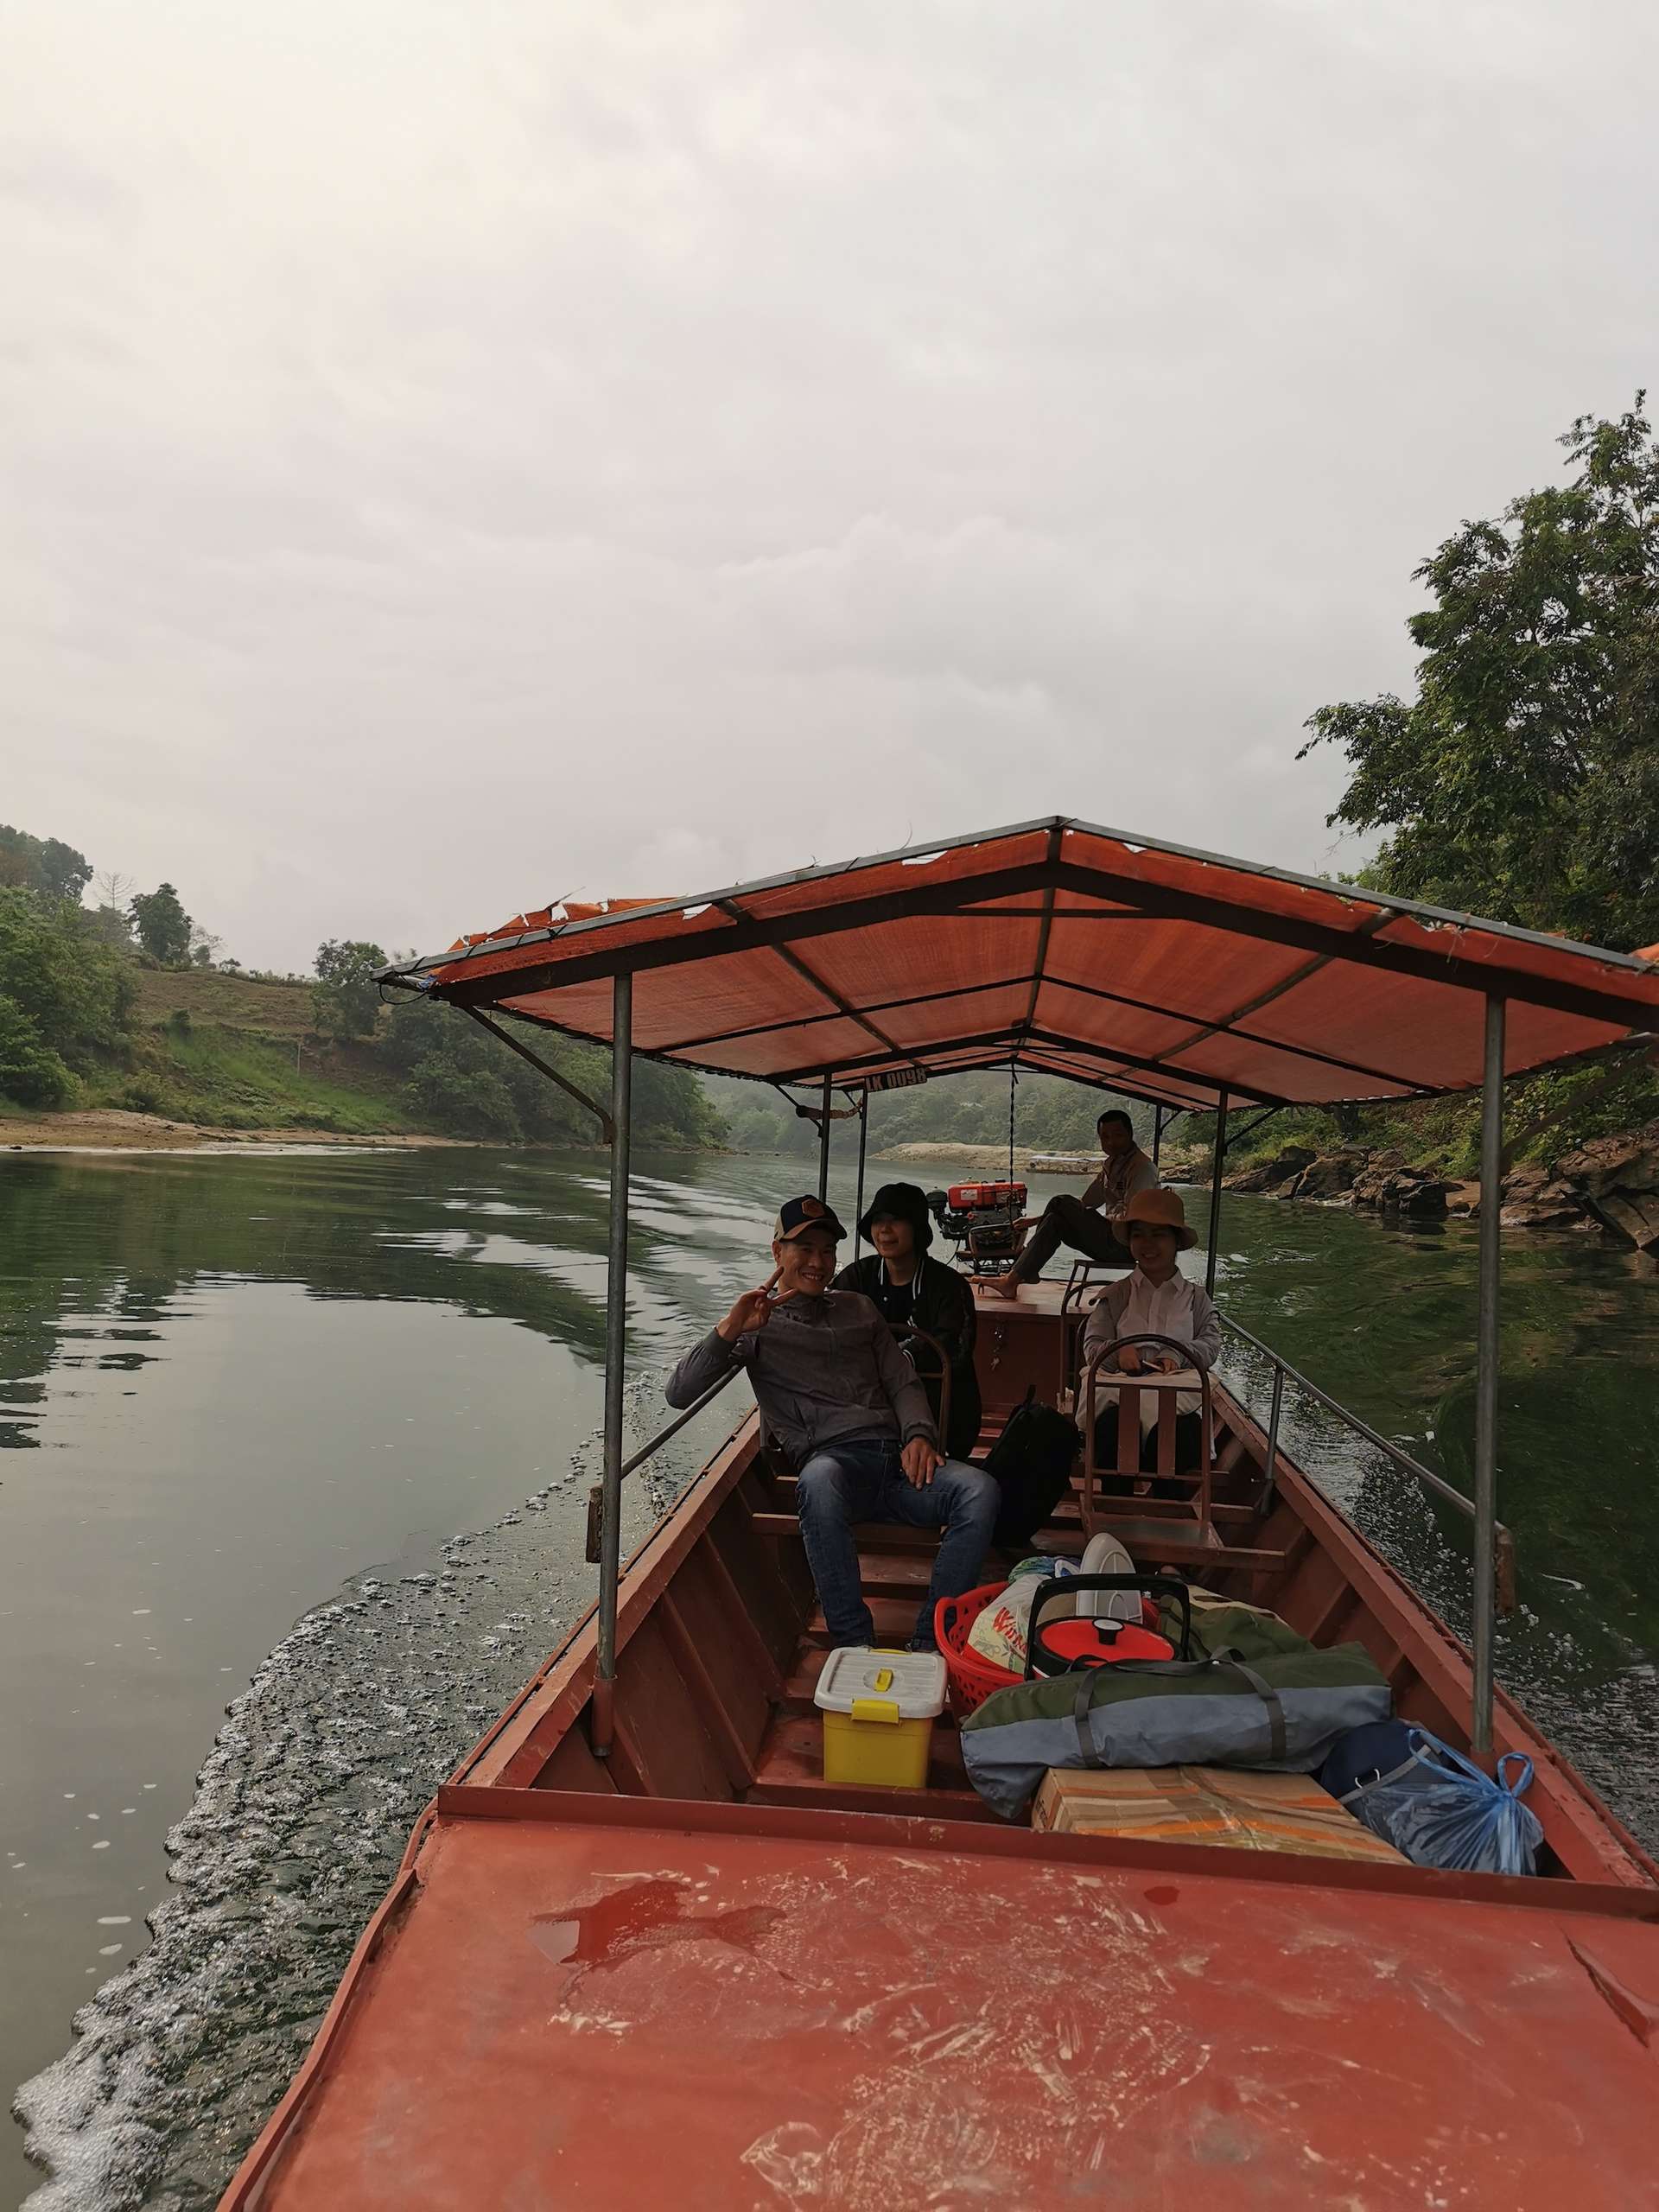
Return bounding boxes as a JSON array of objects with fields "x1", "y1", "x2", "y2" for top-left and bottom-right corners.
[{"x1": 1332, "y1": 1727, "x2": 1544, "y2": 1873}]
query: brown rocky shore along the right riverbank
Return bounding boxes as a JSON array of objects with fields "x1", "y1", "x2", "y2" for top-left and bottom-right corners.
[{"x1": 1221, "y1": 1122, "x2": 1659, "y2": 1256}]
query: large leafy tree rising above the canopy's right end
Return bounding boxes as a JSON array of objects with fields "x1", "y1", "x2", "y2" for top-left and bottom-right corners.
[{"x1": 1296, "y1": 391, "x2": 1659, "y2": 949}]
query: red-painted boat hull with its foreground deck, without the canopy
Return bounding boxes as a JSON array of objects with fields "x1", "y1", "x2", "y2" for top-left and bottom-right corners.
[{"x1": 224, "y1": 832, "x2": 1659, "y2": 2212}]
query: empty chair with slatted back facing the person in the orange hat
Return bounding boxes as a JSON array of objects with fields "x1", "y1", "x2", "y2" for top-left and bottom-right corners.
[{"x1": 1079, "y1": 1334, "x2": 1221, "y2": 1564}]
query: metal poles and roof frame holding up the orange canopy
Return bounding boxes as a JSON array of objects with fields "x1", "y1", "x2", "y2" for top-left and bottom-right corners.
[{"x1": 380, "y1": 818, "x2": 1659, "y2": 1757}]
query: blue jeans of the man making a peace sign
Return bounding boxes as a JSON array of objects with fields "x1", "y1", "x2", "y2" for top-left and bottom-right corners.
[{"x1": 797, "y1": 1435, "x2": 1002, "y2": 1646}]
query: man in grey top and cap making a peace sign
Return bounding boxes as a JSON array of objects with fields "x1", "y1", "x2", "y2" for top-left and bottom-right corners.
[{"x1": 666, "y1": 1197, "x2": 1000, "y2": 1650}]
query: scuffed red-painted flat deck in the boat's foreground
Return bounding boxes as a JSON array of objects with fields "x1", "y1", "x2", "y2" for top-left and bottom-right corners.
[{"x1": 248, "y1": 1787, "x2": 1659, "y2": 2212}]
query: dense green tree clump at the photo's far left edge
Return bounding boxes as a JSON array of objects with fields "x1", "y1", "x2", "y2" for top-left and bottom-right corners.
[{"x1": 0, "y1": 887, "x2": 133, "y2": 1106}]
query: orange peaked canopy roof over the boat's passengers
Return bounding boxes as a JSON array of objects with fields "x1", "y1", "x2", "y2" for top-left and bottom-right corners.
[{"x1": 385, "y1": 818, "x2": 1659, "y2": 1109}]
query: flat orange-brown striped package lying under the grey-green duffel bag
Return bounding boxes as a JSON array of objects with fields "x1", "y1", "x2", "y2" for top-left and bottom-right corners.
[{"x1": 1031, "y1": 1767, "x2": 1405, "y2": 1865}]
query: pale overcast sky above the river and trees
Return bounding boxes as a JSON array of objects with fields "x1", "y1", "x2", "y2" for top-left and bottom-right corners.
[{"x1": 0, "y1": 0, "x2": 1659, "y2": 967}]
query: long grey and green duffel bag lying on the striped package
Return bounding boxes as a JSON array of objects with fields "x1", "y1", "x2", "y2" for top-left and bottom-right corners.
[{"x1": 963, "y1": 1606, "x2": 1394, "y2": 1821}]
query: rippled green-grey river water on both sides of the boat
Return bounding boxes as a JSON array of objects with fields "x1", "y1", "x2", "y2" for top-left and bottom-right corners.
[{"x1": 0, "y1": 1150, "x2": 1659, "y2": 2212}]
